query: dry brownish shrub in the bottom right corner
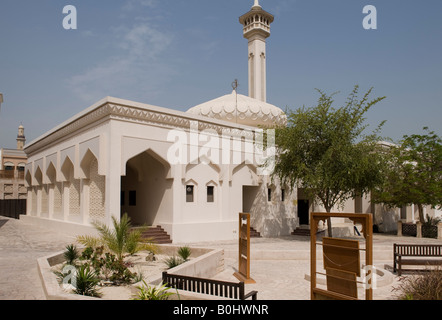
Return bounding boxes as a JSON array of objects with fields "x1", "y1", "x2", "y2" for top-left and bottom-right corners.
[{"x1": 393, "y1": 268, "x2": 442, "y2": 300}]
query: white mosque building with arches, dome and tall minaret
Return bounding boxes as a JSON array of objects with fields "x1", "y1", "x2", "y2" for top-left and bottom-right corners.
[{"x1": 23, "y1": 0, "x2": 308, "y2": 243}]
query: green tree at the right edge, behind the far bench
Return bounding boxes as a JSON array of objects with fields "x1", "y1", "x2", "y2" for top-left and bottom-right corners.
[{"x1": 375, "y1": 127, "x2": 442, "y2": 223}]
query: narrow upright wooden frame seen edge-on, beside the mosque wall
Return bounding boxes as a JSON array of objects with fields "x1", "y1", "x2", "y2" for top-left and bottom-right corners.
[{"x1": 233, "y1": 213, "x2": 256, "y2": 284}]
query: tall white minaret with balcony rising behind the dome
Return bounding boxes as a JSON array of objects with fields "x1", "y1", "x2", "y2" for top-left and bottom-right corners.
[{"x1": 239, "y1": 0, "x2": 274, "y2": 102}]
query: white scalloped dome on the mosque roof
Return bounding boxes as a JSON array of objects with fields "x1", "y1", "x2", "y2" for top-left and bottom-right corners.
[{"x1": 187, "y1": 90, "x2": 287, "y2": 127}]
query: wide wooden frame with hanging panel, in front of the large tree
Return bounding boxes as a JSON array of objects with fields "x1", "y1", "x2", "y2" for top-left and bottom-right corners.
[{"x1": 310, "y1": 212, "x2": 374, "y2": 300}]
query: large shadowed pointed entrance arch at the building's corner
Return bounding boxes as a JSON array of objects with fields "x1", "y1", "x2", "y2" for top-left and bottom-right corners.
[{"x1": 121, "y1": 149, "x2": 173, "y2": 226}]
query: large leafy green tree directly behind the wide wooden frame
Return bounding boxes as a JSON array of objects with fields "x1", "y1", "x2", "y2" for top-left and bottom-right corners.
[{"x1": 273, "y1": 86, "x2": 385, "y2": 236}]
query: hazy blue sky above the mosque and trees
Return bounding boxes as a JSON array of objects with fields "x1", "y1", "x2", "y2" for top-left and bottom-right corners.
[{"x1": 0, "y1": 0, "x2": 442, "y2": 148}]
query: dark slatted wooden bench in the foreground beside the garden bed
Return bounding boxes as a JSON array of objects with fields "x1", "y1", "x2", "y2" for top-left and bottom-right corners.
[{"x1": 163, "y1": 271, "x2": 258, "y2": 300}]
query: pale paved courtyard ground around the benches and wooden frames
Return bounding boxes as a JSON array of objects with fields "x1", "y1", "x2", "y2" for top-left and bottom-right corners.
[{"x1": 0, "y1": 217, "x2": 440, "y2": 300}]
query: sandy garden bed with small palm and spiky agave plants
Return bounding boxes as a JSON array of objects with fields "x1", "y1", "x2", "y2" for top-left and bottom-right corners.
[{"x1": 51, "y1": 215, "x2": 191, "y2": 300}]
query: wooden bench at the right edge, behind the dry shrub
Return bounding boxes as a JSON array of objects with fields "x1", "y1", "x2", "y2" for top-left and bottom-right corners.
[{"x1": 393, "y1": 243, "x2": 442, "y2": 276}]
